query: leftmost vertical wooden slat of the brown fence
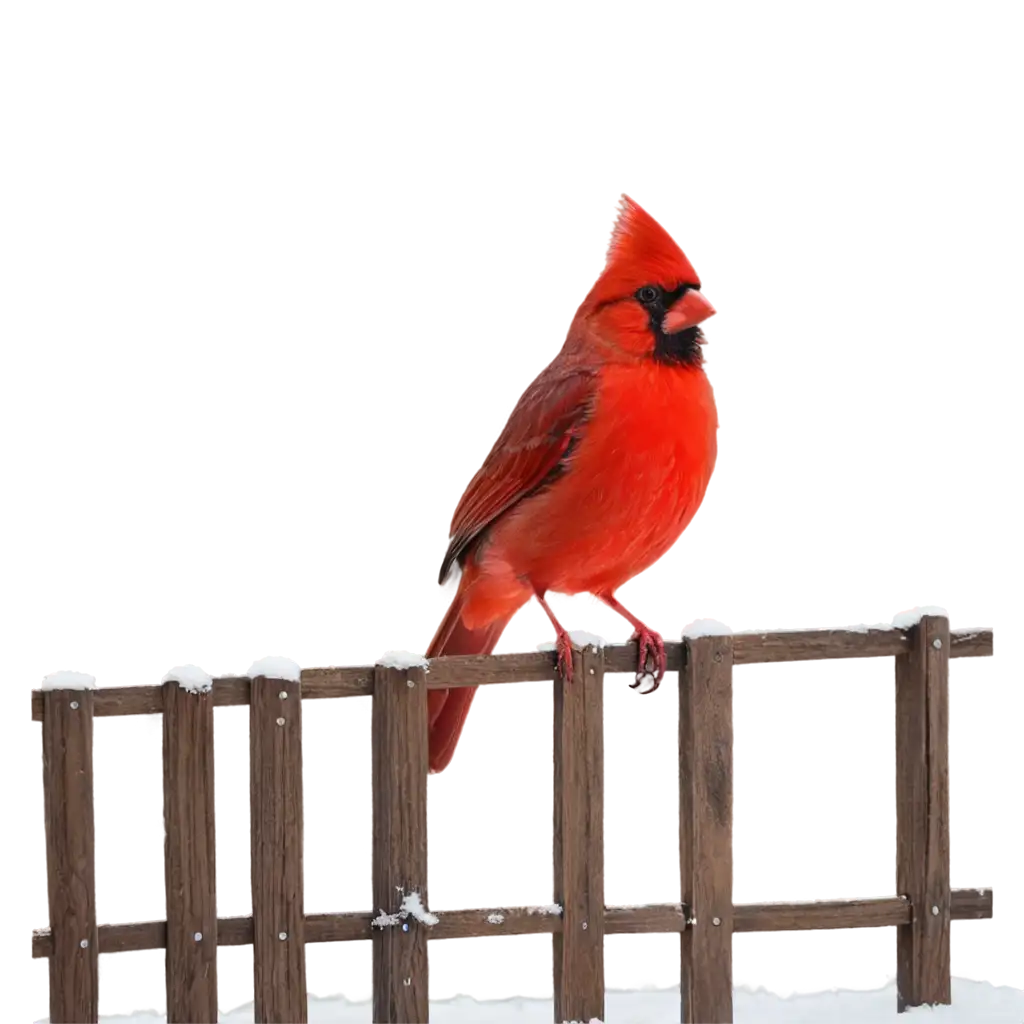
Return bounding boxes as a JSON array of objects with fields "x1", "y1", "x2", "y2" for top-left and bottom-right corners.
[{"x1": 43, "y1": 690, "x2": 99, "y2": 1024}]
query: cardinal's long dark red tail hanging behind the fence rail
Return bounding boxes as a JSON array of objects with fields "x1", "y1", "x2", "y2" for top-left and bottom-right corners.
[{"x1": 426, "y1": 575, "x2": 512, "y2": 772}]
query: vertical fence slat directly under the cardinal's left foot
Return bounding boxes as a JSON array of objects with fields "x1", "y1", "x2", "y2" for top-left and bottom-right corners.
[{"x1": 552, "y1": 647, "x2": 606, "y2": 1024}]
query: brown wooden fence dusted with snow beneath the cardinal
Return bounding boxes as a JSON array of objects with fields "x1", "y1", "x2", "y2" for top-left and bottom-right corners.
[{"x1": 32, "y1": 616, "x2": 996, "y2": 1024}]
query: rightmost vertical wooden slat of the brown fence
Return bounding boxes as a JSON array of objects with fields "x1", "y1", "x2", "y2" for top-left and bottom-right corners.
[{"x1": 889, "y1": 615, "x2": 952, "y2": 1013}]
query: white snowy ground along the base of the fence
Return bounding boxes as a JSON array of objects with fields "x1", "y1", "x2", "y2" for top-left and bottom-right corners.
[{"x1": 46, "y1": 971, "x2": 1024, "y2": 1024}]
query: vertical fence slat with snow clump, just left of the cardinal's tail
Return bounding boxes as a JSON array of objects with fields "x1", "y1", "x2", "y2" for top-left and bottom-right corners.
[{"x1": 370, "y1": 666, "x2": 430, "y2": 1024}]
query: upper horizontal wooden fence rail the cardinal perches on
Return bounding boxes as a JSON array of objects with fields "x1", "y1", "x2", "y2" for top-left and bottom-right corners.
[{"x1": 30, "y1": 629, "x2": 993, "y2": 718}]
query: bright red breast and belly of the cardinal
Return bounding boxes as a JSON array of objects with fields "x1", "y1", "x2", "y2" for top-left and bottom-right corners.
[{"x1": 463, "y1": 337, "x2": 717, "y2": 629}]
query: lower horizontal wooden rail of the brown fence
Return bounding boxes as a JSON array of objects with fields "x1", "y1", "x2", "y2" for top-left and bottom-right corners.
[{"x1": 31, "y1": 883, "x2": 999, "y2": 956}]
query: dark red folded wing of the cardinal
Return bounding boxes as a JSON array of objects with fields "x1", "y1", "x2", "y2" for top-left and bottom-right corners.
[{"x1": 435, "y1": 367, "x2": 596, "y2": 583}]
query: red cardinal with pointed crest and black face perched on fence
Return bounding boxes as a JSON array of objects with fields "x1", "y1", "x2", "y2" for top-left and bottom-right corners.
[{"x1": 426, "y1": 194, "x2": 718, "y2": 772}]
